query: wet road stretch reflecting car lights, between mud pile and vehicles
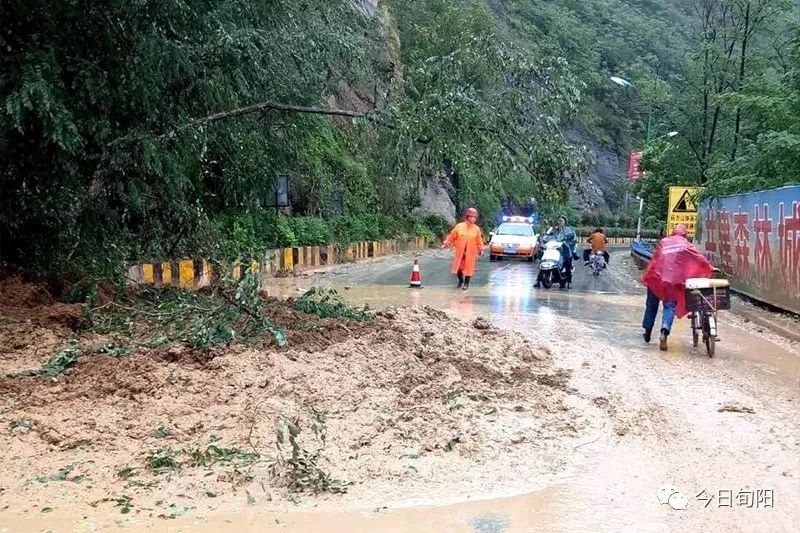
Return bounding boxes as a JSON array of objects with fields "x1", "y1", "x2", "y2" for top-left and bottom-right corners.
[{"x1": 306, "y1": 247, "x2": 644, "y2": 330}]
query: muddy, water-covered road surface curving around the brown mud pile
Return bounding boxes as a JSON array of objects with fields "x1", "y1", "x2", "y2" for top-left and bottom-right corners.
[{"x1": 0, "y1": 253, "x2": 800, "y2": 533}]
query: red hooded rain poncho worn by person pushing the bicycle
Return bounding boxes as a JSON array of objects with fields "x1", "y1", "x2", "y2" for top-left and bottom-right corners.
[{"x1": 642, "y1": 227, "x2": 714, "y2": 318}]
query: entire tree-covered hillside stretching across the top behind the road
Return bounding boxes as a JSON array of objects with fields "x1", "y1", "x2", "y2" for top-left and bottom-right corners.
[{"x1": 0, "y1": 0, "x2": 800, "y2": 278}]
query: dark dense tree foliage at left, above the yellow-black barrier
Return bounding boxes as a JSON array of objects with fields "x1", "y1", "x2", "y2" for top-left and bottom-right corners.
[{"x1": 0, "y1": 0, "x2": 381, "y2": 271}]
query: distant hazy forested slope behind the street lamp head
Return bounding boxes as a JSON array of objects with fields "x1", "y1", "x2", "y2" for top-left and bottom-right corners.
[{"x1": 504, "y1": 0, "x2": 693, "y2": 152}]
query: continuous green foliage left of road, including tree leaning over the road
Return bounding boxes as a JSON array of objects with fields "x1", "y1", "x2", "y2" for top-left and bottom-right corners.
[{"x1": 0, "y1": 0, "x2": 592, "y2": 275}]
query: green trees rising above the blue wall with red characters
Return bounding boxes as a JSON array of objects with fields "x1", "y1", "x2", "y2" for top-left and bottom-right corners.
[{"x1": 639, "y1": 0, "x2": 800, "y2": 221}]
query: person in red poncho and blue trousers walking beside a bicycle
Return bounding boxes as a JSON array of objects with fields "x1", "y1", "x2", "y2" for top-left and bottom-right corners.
[{"x1": 642, "y1": 224, "x2": 714, "y2": 351}]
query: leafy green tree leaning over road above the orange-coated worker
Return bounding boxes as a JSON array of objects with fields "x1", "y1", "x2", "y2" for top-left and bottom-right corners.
[{"x1": 388, "y1": 0, "x2": 585, "y2": 219}]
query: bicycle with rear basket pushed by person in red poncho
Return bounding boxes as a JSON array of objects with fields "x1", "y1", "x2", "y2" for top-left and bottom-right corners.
[{"x1": 686, "y1": 269, "x2": 731, "y2": 357}]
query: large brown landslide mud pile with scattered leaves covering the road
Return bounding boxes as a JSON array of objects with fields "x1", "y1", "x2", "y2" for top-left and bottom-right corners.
[{"x1": 0, "y1": 274, "x2": 581, "y2": 513}]
